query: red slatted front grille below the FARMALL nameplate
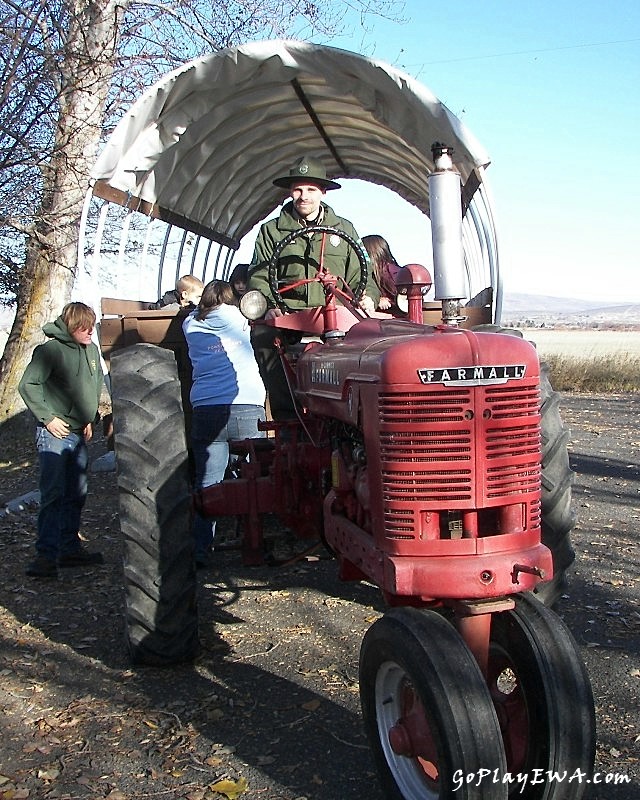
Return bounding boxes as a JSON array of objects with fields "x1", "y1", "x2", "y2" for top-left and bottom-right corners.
[{"x1": 379, "y1": 381, "x2": 540, "y2": 538}]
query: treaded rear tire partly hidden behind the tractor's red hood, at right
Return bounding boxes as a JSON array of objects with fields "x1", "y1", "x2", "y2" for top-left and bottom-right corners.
[{"x1": 473, "y1": 325, "x2": 576, "y2": 606}]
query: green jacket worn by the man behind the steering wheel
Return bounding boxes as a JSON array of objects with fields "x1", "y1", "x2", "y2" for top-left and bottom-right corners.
[{"x1": 248, "y1": 202, "x2": 380, "y2": 309}]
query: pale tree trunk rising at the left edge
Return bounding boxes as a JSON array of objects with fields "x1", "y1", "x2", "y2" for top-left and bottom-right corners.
[{"x1": 0, "y1": 0, "x2": 127, "y2": 425}]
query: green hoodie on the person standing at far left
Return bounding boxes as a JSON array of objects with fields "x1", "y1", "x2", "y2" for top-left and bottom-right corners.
[{"x1": 18, "y1": 317, "x2": 103, "y2": 433}]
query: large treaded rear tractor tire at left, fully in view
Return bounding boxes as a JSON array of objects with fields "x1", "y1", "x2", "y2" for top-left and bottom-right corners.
[{"x1": 111, "y1": 344, "x2": 199, "y2": 666}]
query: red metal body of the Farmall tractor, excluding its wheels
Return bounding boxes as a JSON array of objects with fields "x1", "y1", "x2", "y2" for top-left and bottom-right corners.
[{"x1": 196, "y1": 282, "x2": 552, "y2": 624}]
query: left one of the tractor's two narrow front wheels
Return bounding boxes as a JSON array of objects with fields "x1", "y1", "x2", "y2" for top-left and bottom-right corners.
[{"x1": 360, "y1": 608, "x2": 507, "y2": 800}]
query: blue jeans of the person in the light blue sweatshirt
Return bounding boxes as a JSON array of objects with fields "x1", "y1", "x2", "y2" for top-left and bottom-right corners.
[{"x1": 191, "y1": 405, "x2": 266, "y2": 561}]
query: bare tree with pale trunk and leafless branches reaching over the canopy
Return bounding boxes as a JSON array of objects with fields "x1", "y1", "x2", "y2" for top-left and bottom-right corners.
[{"x1": 0, "y1": 0, "x2": 398, "y2": 425}]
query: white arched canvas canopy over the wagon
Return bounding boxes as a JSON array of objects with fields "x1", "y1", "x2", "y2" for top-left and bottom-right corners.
[{"x1": 85, "y1": 41, "x2": 497, "y2": 312}]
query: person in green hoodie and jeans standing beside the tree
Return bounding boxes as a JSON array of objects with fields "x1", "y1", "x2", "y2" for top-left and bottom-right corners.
[{"x1": 18, "y1": 303, "x2": 104, "y2": 578}]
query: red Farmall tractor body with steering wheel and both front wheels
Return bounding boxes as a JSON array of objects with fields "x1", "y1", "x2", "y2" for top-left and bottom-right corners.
[{"x1": 196, "y1": 228, "x2": 594, "y2": 800}]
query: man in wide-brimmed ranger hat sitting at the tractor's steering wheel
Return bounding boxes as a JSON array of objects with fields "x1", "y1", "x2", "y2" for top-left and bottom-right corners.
[{"x1": 248, "y1": 156, "x2": 380, "y2": 420}]
